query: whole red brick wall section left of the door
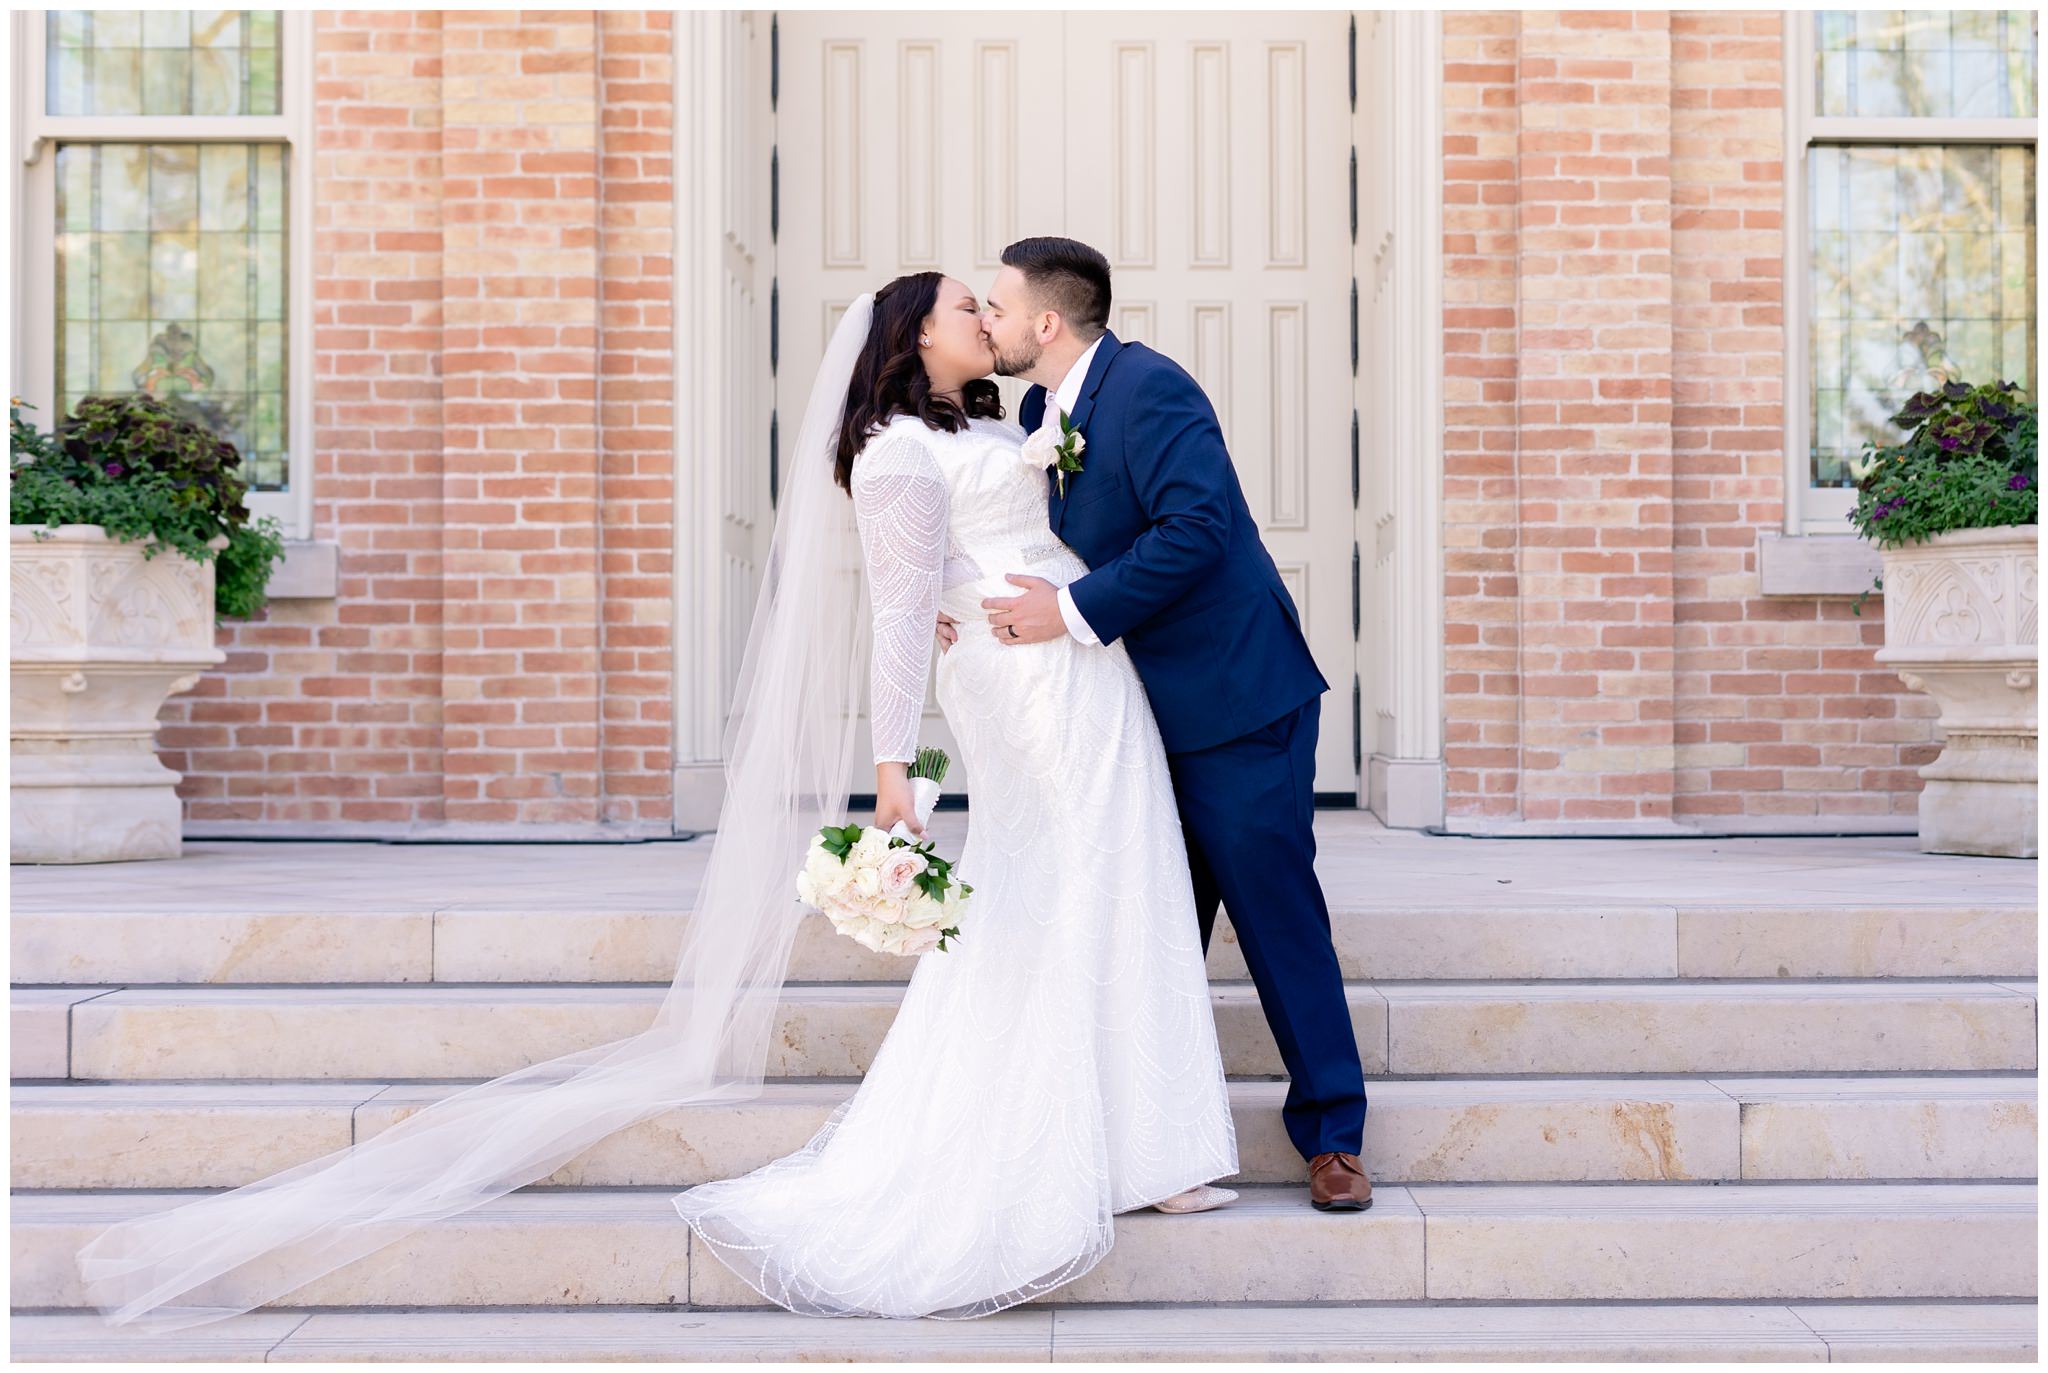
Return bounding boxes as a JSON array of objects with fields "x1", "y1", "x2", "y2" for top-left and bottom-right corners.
[{"x1": 160, "y1": 10, "x2": 672, "y2": 832}]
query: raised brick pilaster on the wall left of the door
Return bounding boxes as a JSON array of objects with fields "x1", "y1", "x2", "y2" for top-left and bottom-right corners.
[{"x1": 440, "y1": 10, "x2": 600, "y2": 824}]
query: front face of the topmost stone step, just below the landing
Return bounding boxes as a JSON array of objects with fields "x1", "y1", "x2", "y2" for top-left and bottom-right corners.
[{"x1": 10, "y1": 901, "x2": 2036, "y2": 986}]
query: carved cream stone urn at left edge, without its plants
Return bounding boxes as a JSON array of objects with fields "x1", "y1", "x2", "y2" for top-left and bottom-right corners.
[{"x1": 8, "y1": 525, "x2": 227, "y2": 863}]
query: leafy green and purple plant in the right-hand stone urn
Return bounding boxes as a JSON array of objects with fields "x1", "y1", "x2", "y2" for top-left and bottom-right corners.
[{"x1": 1847, "y1": 381, "x2": 2040, "y2": 615}]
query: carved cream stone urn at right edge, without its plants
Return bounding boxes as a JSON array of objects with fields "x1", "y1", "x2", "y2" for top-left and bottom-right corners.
[{"x1": 1876, "y1": 525, "x2": 2040, "y2": 859}]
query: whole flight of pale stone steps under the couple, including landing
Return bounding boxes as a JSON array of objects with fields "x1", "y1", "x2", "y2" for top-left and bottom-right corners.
[{"x1": 10, "y1": 848, "x2": 2038, "y2": 1361}]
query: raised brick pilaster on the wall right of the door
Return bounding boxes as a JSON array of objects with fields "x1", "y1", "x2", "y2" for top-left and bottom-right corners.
[{"x1": 1516, "y1": 10, "x2": 1673, "y2": 822}]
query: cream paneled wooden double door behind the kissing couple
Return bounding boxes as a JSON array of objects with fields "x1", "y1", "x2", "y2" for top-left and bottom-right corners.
[{"x1": 772, "y1": 10, "x2": 1358, "y2": 793}]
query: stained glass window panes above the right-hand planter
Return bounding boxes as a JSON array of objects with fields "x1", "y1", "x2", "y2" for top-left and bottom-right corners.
[{"x1": 1806, "y1": 10, "x2": 2038, "y2": 488}]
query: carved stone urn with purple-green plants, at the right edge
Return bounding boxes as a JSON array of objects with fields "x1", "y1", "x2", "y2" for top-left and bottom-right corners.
[{"x1": 1849, "y1": 381, "x2": 2040, "y2": 859}]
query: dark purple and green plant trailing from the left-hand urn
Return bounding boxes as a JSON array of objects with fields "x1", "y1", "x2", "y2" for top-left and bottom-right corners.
[{"x1": 8, "y1": 393, "x2": 285, "y2": 617}]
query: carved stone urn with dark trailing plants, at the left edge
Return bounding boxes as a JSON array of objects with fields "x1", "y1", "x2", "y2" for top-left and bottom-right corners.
[{"x1": 8, "y1": 396, "x2": 285, "y2": 863}]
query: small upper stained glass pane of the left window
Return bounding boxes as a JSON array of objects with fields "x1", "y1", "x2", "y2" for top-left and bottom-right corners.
[{"x1": 45, "y1": 10, "x2": 281, "y2": 115}]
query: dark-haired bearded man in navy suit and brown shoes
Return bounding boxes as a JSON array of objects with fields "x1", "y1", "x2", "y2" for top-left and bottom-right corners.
[{"x1": 940, "y1": 238, "x2": 1372, "y2": 1211}]
